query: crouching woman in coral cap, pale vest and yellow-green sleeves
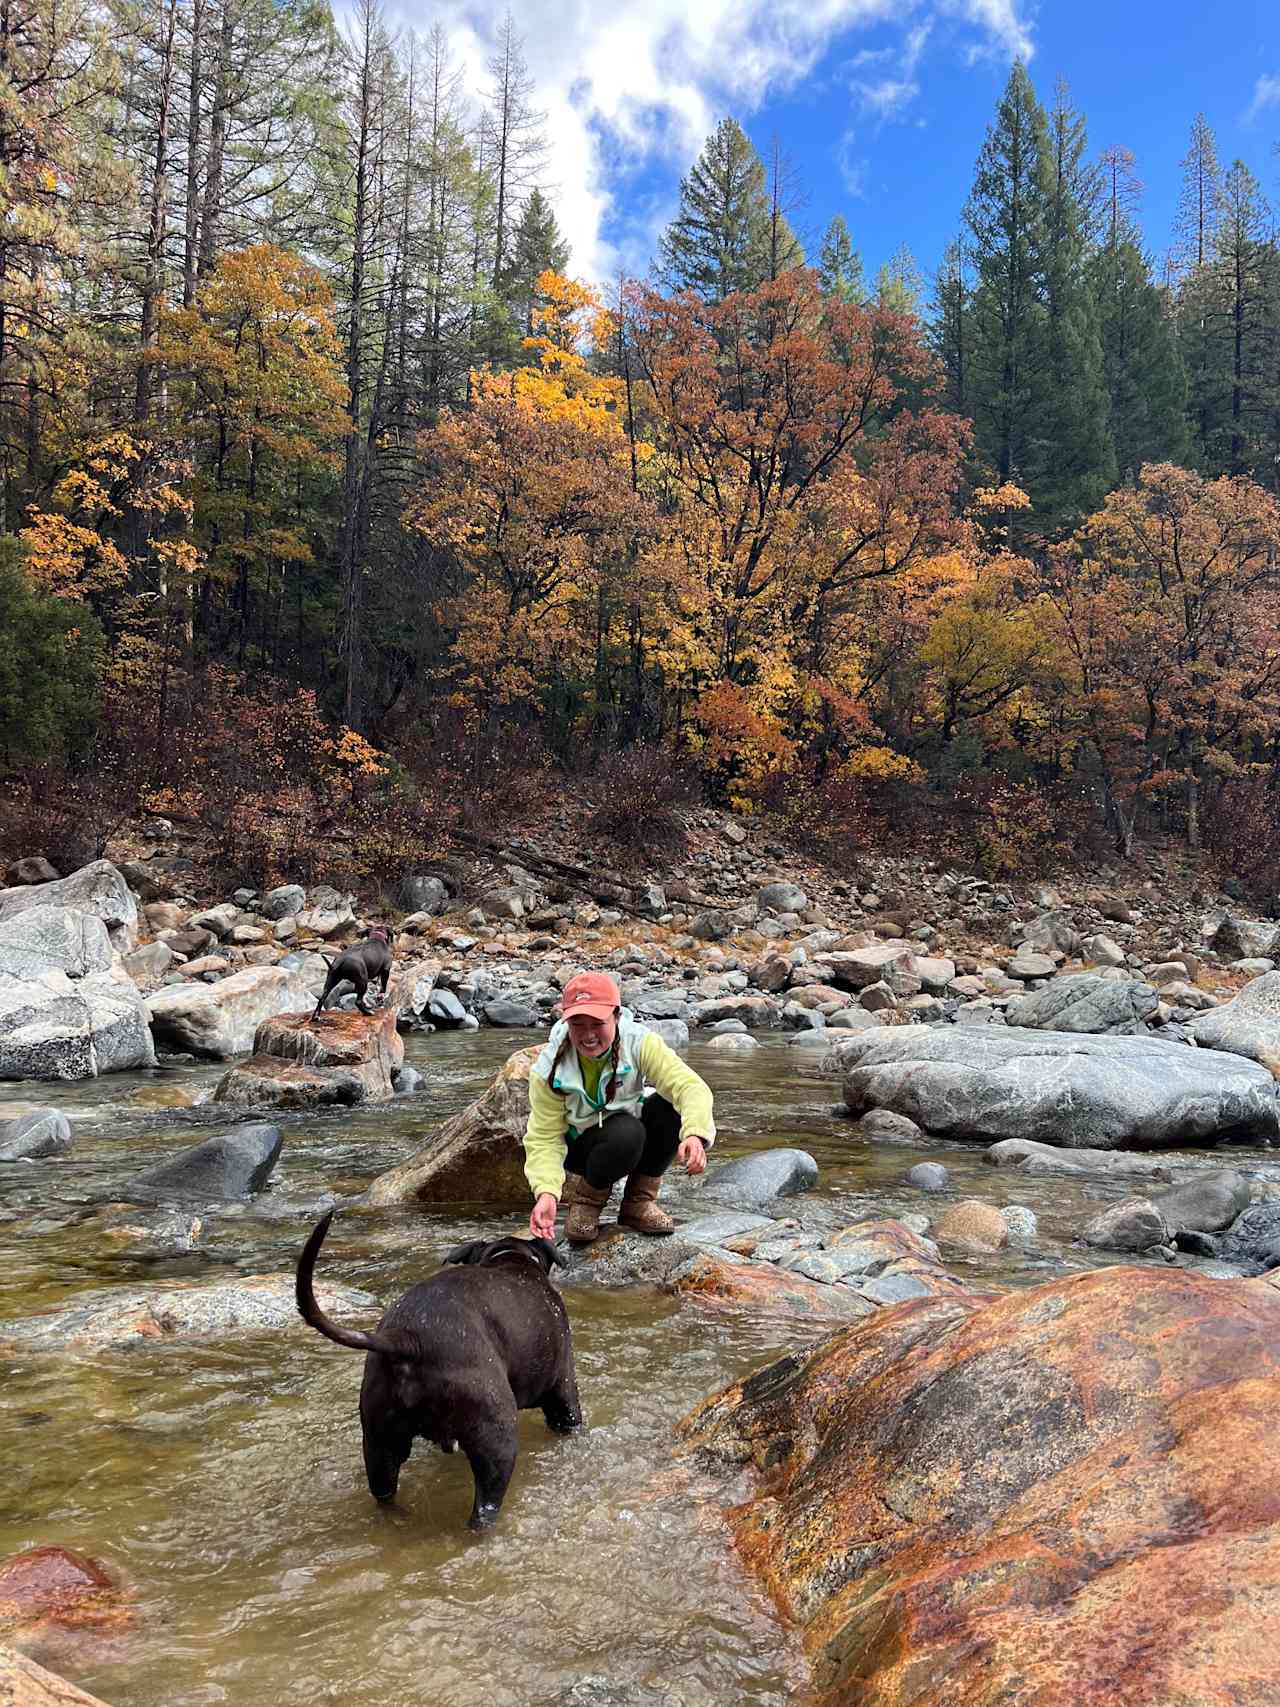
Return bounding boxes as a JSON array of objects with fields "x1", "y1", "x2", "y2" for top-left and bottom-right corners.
[{"x1": 524, "y1": 971, "x2": 715, "y2": 1244}]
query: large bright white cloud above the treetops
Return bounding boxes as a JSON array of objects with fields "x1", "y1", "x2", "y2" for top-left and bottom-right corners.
[{"x1": 389, "y1": 0, "x2": 1031, "y2": 282}]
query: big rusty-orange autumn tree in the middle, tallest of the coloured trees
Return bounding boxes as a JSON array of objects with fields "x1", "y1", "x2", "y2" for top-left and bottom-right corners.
[{"x1": 631, "y1": 270, "x2": 963, "y2": 792}]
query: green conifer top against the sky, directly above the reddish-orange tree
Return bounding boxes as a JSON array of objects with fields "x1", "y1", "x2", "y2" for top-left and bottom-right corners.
[{"x1": 659, "y1": 118, "x2": 804, "y2": 302}]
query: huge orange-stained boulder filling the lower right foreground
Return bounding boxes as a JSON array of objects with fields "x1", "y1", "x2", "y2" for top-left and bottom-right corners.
[{"x1": 679, "y1": 1268, "x2": 1280, "y2": 1707}]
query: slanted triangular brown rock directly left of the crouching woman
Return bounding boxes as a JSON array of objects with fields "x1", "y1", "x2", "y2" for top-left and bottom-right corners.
[{"x1": 365, "y1": 1048, "x2": 541, "y2": 1209}]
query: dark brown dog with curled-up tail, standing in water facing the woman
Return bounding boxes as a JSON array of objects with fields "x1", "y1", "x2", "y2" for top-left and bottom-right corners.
[{"x1": 297, "y1": 1210, "x2": 582, "y2": 1529}]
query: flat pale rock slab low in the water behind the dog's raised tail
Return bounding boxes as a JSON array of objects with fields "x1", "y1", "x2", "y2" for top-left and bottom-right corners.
[{"x1": 0, "y1": 1273, "x2": 379, "y2": 1355}]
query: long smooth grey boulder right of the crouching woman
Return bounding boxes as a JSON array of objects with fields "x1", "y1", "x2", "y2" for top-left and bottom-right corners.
[{"x1": 836, "y1": 1026, "x2": 1280, "y2": 1149}]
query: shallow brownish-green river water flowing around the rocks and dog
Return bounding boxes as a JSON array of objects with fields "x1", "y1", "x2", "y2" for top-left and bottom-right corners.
[{"x1": 0, "y1": 1031, "x2": 1273, "y2": 1707}]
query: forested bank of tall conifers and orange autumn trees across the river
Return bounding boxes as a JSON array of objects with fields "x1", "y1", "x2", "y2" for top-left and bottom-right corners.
[{"x1": 0, "y1": 0, "x2": 1280, "y2": 893}]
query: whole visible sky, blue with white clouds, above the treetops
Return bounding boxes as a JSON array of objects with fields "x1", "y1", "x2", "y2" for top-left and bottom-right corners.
[{"x1": 398, "y1": 0, "x2": 1280, "y2": 290}]
